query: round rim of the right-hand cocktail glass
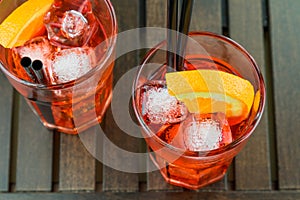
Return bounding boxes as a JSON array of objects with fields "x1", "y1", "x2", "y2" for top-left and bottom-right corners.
[{"x1": 132, "y1": 31, "x2": 266, "y2": 159}]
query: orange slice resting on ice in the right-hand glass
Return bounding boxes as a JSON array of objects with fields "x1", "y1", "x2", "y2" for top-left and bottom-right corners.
[{"x1": 166, "y1": 70, "x2": 254, "y2": 125}]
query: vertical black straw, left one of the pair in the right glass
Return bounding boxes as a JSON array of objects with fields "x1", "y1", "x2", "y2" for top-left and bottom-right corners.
[{"x1": 167, "y1": 0, "x2": 178, "y2": 70}]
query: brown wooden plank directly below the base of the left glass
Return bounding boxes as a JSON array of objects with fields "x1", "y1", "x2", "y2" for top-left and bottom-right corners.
[{"x1": 59, "y1": 129, "x2": 96, "y2": 191}]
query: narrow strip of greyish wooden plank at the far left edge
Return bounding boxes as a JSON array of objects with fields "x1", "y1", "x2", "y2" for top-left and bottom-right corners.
[{"x1": 0, "y1": 73, "x2": 13, "y2": 192}]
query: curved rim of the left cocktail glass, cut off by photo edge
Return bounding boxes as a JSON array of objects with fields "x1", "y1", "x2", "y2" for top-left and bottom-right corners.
[{"x1": 0, "y1": 0, "x2": 118, "y2": 90}]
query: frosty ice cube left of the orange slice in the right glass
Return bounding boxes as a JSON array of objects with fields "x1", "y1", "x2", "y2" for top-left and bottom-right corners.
[{"x1": 141, "y1": 81, "x2": 188, "y2": 124}]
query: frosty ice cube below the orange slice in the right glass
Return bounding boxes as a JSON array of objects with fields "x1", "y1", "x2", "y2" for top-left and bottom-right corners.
[{"x1": 178, "y1": 113, "x2": 232, "y2": 151}]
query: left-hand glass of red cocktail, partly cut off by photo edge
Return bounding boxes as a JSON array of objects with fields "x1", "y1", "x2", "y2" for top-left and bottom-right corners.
[{"x1": 0, "y1": 0, "x2": 117, "y2": 134}]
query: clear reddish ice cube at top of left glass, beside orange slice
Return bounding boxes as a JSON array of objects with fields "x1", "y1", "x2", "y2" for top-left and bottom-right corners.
[{"x1": 44, "y1": 0, "x2": 97, "y2": 47}]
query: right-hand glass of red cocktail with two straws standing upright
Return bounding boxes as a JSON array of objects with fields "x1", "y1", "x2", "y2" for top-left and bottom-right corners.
[{"x1": 133, "y1": 32, "x2": 265, "y2": 189}]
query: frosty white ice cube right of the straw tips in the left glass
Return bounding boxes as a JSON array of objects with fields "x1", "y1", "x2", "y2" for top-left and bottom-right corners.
[{"x1": 49, "y1": 47, "x2": 92, "y2": 84}]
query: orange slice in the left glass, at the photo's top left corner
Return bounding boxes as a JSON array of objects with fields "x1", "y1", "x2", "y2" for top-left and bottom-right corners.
[{"x1": 0, "y1": 0, "x2": 53, "y2": 48}]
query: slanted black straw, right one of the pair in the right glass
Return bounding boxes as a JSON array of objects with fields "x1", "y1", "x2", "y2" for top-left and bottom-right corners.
[{"x1": 176, "y1": 0, "x2": 194, "y2": 71}]
